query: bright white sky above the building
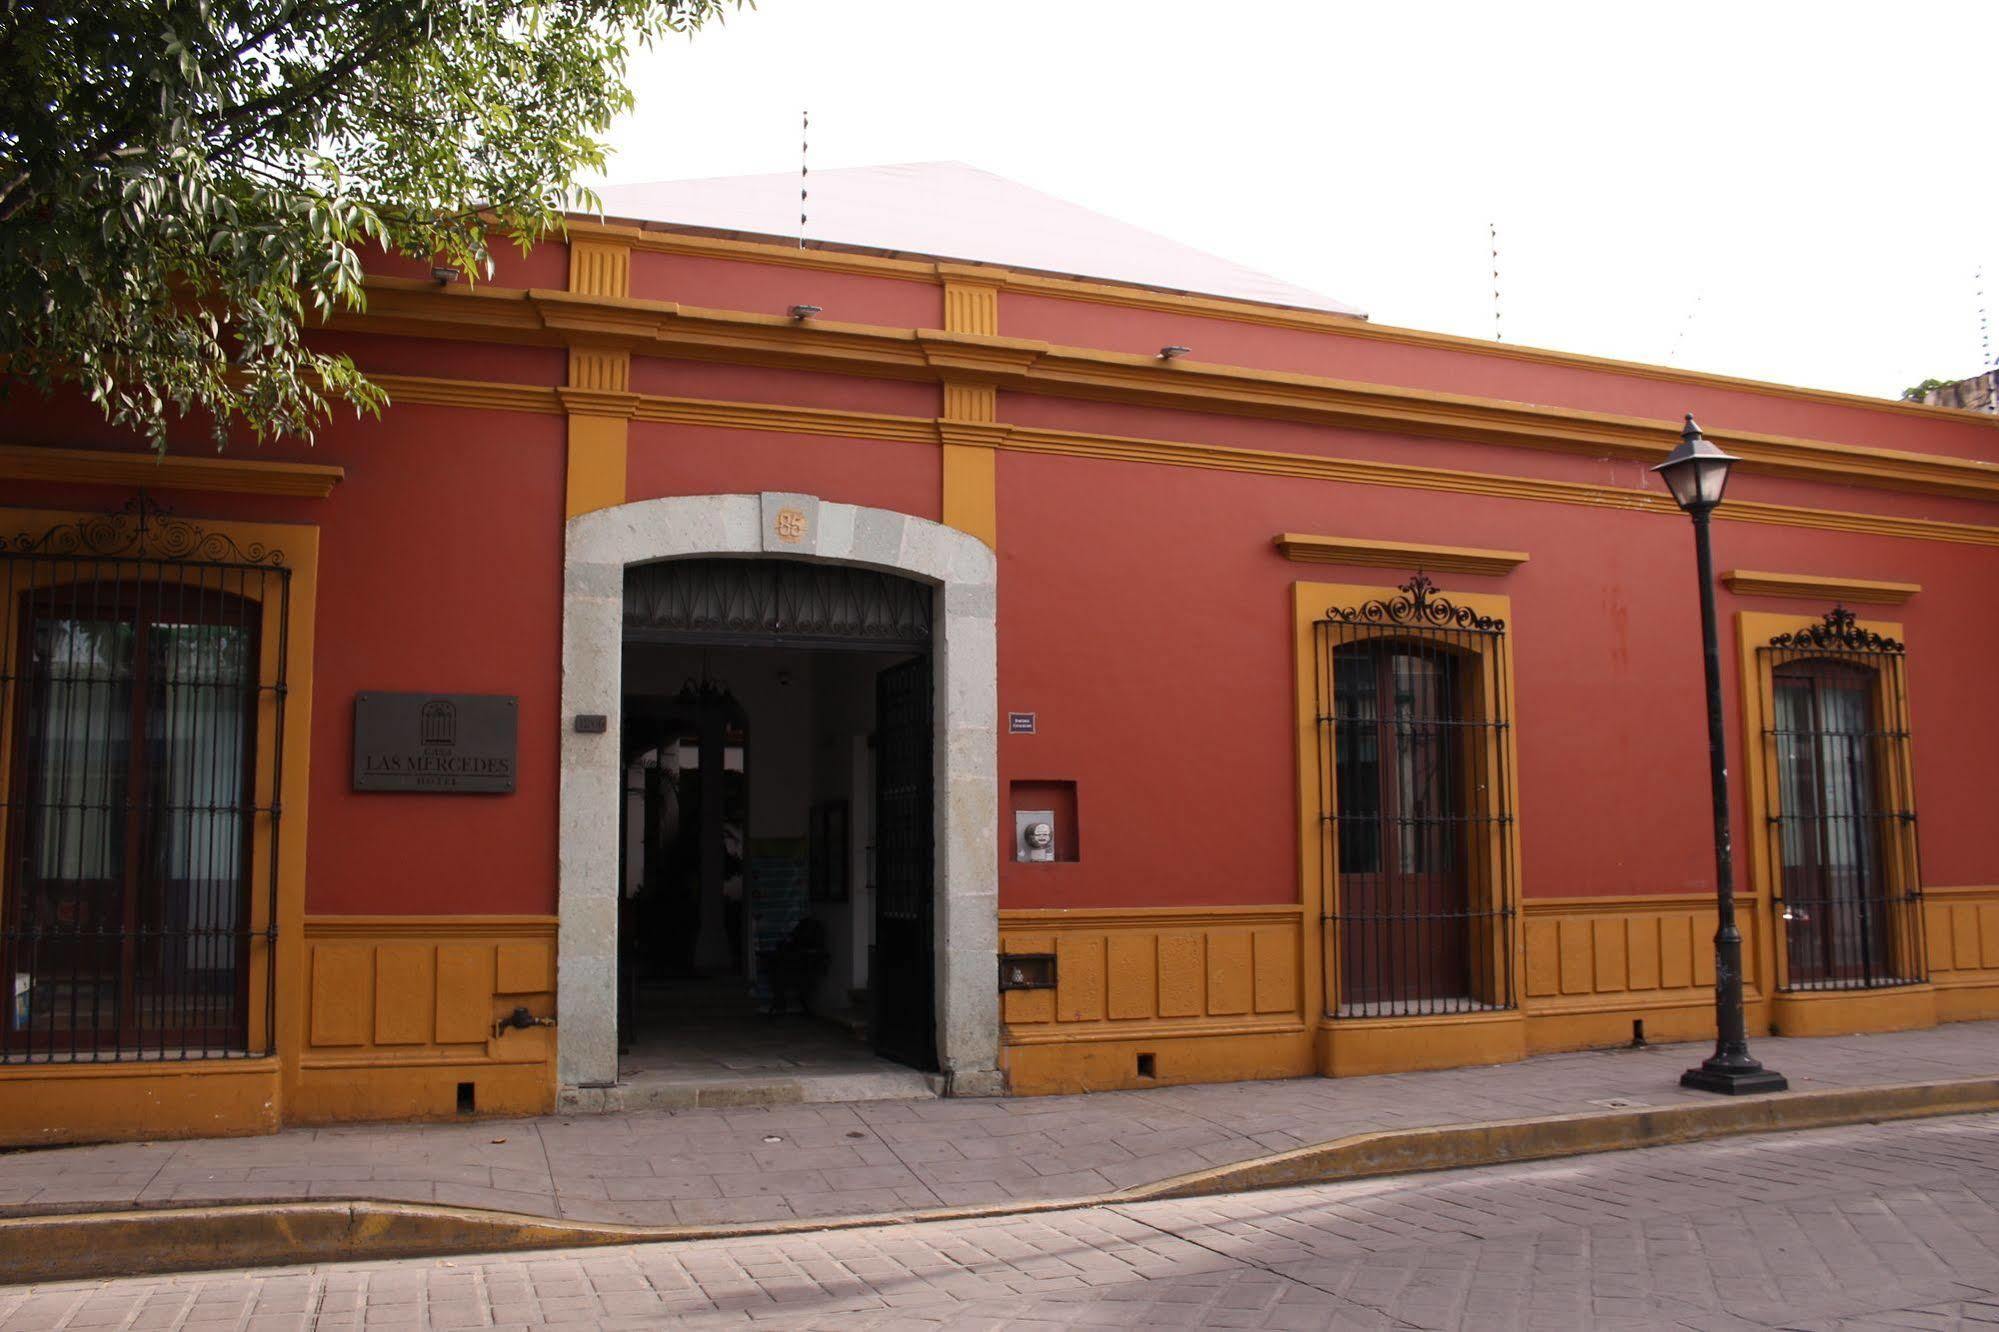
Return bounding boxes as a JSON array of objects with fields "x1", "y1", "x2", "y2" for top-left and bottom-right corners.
[{"x1": 608, "y1": 0, "x2": 1999, "y2": 396}]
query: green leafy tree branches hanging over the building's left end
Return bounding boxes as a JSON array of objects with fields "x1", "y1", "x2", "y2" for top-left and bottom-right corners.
[{"x1": 0, "y1": 0, "x2": 740, "y2": 448}]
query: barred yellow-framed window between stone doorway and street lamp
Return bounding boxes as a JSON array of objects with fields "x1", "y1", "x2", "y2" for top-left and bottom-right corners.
[{"x1": 1313, "y1": 572, "x2": 1517, "y2": 1018}]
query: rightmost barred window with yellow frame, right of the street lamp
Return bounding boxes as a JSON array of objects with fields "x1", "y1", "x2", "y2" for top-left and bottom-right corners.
[{"x1": 1757, "y1": 606, "x2": 1927, "y2": 990}]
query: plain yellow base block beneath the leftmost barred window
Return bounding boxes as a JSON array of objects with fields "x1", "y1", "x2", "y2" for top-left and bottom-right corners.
[{"x1": 0, "y1": 1058, "x2": 282, "y2": 1148}]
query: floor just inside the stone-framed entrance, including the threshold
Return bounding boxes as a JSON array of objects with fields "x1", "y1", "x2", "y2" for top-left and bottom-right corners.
[{"x1": 612, "y1": 978, "x2": 940, "y2": 1110}]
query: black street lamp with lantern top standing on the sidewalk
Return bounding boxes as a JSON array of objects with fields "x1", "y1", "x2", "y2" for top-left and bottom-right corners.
[{"x1": 1653, "y1": 414, "x2": 1791, "y2": 1096}]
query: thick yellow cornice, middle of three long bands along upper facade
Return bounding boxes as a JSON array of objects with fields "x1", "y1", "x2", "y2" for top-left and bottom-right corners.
[{"x1": 334, "y1": 278, "x2": 1999, "y2": 500}]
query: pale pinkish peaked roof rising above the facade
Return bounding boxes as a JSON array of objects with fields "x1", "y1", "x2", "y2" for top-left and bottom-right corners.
[{"x1": 598, "y1": 162, "x2": 1365, "y2": 318}]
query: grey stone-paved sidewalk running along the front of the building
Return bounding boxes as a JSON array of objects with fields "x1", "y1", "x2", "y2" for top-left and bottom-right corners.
[{"x1": 0, "y1": 1022, "x2": 1999, "y2": 1226}]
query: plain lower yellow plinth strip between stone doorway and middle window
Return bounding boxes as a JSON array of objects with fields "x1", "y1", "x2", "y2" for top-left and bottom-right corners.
[{"x1": 1000, "y1": 1030, "x2": 1313, "y2": 1096}]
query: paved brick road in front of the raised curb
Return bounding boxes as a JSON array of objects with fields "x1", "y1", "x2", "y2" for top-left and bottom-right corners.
[{"x1": 0, "y1": 1116, "x2": 1999, "y2": 1330}]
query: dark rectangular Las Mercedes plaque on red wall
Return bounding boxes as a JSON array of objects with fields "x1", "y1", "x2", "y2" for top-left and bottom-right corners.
[{"x1": 354, "y1": 692, "x2": 520, "y2": 794}]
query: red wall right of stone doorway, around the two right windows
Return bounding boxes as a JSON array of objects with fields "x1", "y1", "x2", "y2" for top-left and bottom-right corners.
[{"x1": 1000, "y1": 440, "x2": 1999, "y2": 908}]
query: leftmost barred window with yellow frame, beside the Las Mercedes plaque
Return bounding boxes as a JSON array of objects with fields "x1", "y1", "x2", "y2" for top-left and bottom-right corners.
[{"x1": 0, "y1": 496, "x2": 292, "y2": 1064}]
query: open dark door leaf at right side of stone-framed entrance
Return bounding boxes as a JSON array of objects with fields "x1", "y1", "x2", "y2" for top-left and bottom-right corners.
[{"x1": 872, "y1": 656, "x2": 938, "y2": 1068}]
